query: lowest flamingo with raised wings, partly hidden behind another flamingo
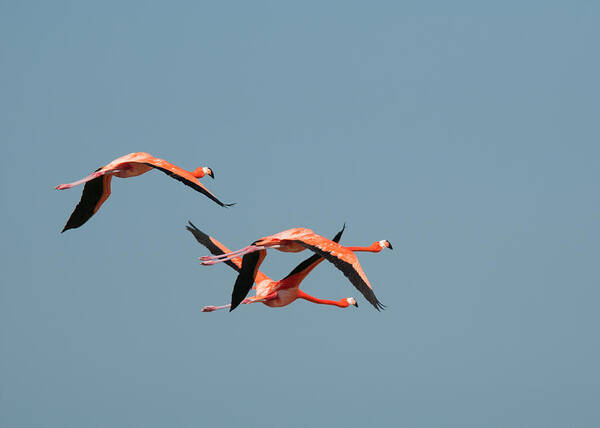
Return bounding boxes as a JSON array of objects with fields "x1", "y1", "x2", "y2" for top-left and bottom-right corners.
[{"x1": 186, "y1": 222, "x2": 358, "y2": 312}]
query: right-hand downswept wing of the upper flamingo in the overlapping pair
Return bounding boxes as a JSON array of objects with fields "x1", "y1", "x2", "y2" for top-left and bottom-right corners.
[{"x1": 295, "y1": 234, "x2": 385, "y2": 311}]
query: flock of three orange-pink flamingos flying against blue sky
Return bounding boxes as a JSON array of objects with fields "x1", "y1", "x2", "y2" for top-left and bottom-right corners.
[{"x1": 56, "y1": 152, "x2": 392, "y2": 312}]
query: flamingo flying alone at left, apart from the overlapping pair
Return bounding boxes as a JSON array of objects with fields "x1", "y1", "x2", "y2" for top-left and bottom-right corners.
[{"x1": 56, "y1": 152, "x2": 234, "y2": 233}]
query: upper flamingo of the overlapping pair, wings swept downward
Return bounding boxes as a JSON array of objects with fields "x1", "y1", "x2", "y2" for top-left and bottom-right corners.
[{"x1": 200, "y1": 227, "x2": 392, "y2": 311}]
